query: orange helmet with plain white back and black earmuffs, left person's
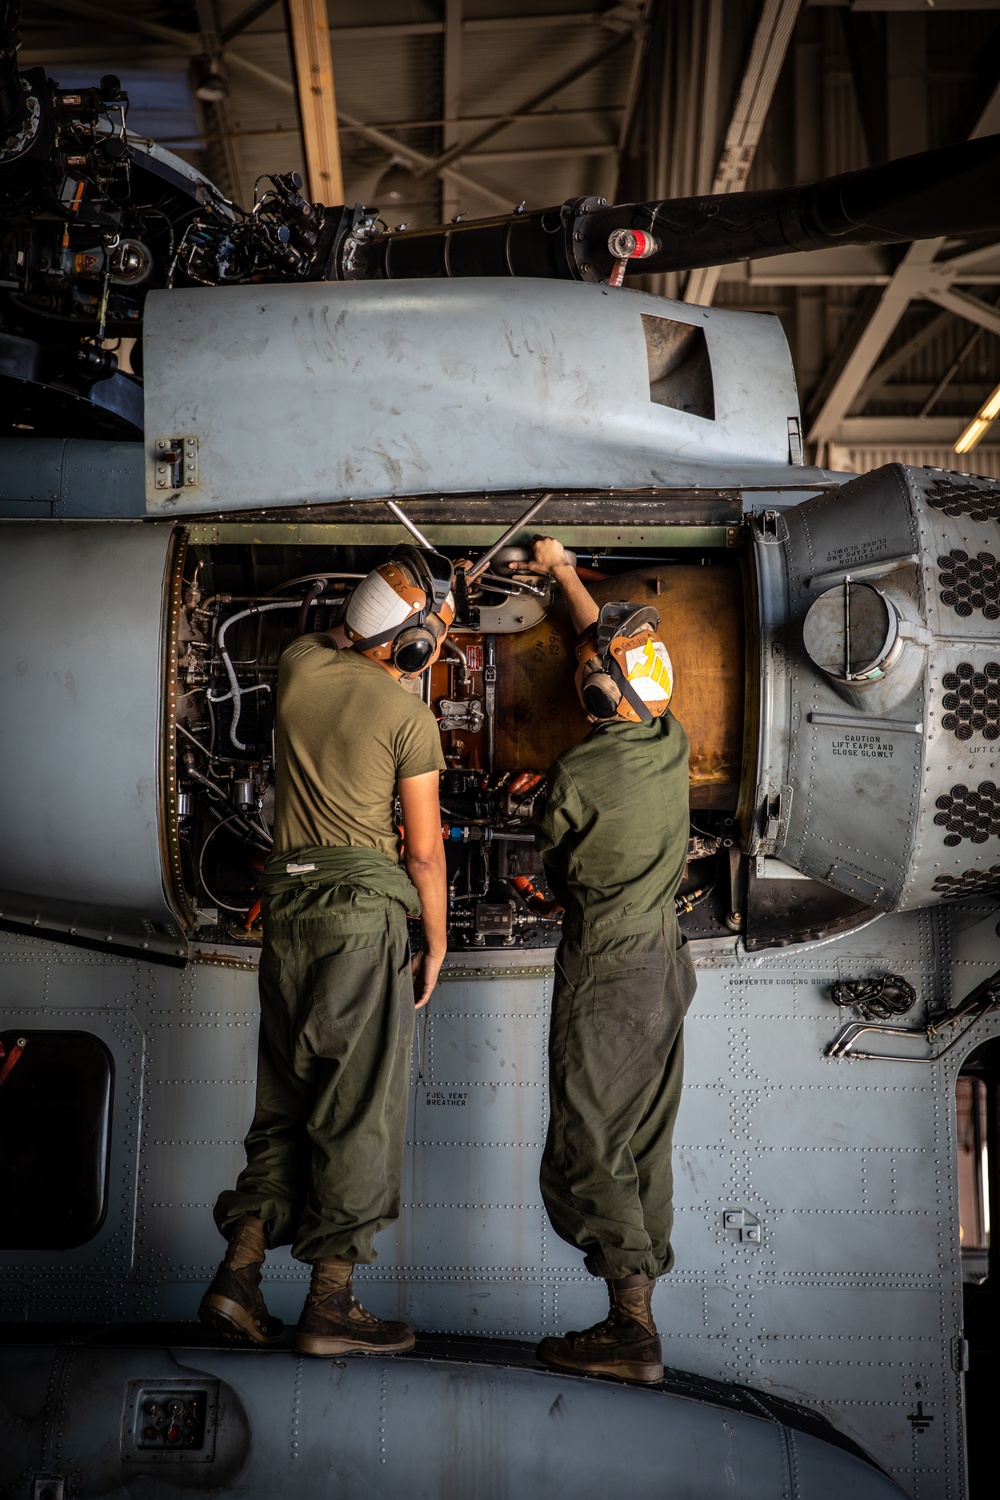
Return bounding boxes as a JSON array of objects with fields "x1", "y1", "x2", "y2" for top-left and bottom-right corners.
[{"x1": 343, "y1": 546, "x2": 454, "y2": 677}]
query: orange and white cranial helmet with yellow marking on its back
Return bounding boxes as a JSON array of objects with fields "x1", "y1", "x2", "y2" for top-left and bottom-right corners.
[{"x1": 576, "y1": 600, "x2": 673, "y2": 725}]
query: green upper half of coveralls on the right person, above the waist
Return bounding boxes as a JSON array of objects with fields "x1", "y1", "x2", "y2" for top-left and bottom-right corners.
[{"x1": 535, "y1": 713, "x2": 690, "y2": 932}]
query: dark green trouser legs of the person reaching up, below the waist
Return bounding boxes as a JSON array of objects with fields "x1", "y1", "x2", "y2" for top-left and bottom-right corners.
[{"x1": 540, "y1": 912, "x2": 696, "y2": 1281}]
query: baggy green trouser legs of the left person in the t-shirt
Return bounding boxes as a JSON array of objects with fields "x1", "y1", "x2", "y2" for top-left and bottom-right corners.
[{"x1": 216, "y1": 882, "x2": 414, "y2": 1263}]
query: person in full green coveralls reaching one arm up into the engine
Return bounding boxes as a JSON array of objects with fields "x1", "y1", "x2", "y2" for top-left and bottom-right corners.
[{"x1": 532, "y1": 537, "x2": 696, "y2": 1382}]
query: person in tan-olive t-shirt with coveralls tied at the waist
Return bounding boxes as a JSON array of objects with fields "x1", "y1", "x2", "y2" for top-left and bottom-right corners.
[{"x1": 199, "y1": 548, "x2": 454, "y2": 1356}]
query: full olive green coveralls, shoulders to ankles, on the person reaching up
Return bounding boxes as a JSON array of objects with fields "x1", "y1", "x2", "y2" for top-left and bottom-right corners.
[{"x1": 537, "y1": 713, "x2": 696, "y2": 1281}]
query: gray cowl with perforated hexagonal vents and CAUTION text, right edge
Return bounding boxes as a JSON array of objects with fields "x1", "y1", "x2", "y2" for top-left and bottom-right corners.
[{"x1": 754, "y1": 465, "x2": 1000, "y2": 909}]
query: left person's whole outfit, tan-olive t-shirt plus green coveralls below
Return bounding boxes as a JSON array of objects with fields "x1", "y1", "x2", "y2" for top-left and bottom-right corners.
[{"x1": 216, "y1": 635, "x2": 444, "y2": 1265}]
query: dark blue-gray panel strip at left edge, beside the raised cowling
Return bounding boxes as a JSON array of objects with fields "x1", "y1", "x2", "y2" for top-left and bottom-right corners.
[{"x1": 0, "y1": 438, "x2": 145, "y2": 521}]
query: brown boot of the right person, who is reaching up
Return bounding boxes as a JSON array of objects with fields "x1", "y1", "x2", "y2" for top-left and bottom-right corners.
[{"x1": 535, "y1": 1272, "x2": 663, "y2": 1385}]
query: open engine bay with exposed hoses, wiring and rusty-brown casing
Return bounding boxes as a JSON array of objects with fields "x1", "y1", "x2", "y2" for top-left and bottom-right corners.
[{"x1": 165, "y1": 507, "x2": 745, "y2": 951}]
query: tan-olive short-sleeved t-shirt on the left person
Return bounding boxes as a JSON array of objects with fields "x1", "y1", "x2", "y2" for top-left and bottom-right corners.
[{"x1": 274, "y1": 635, "x2": 445, "y2": 861}]
